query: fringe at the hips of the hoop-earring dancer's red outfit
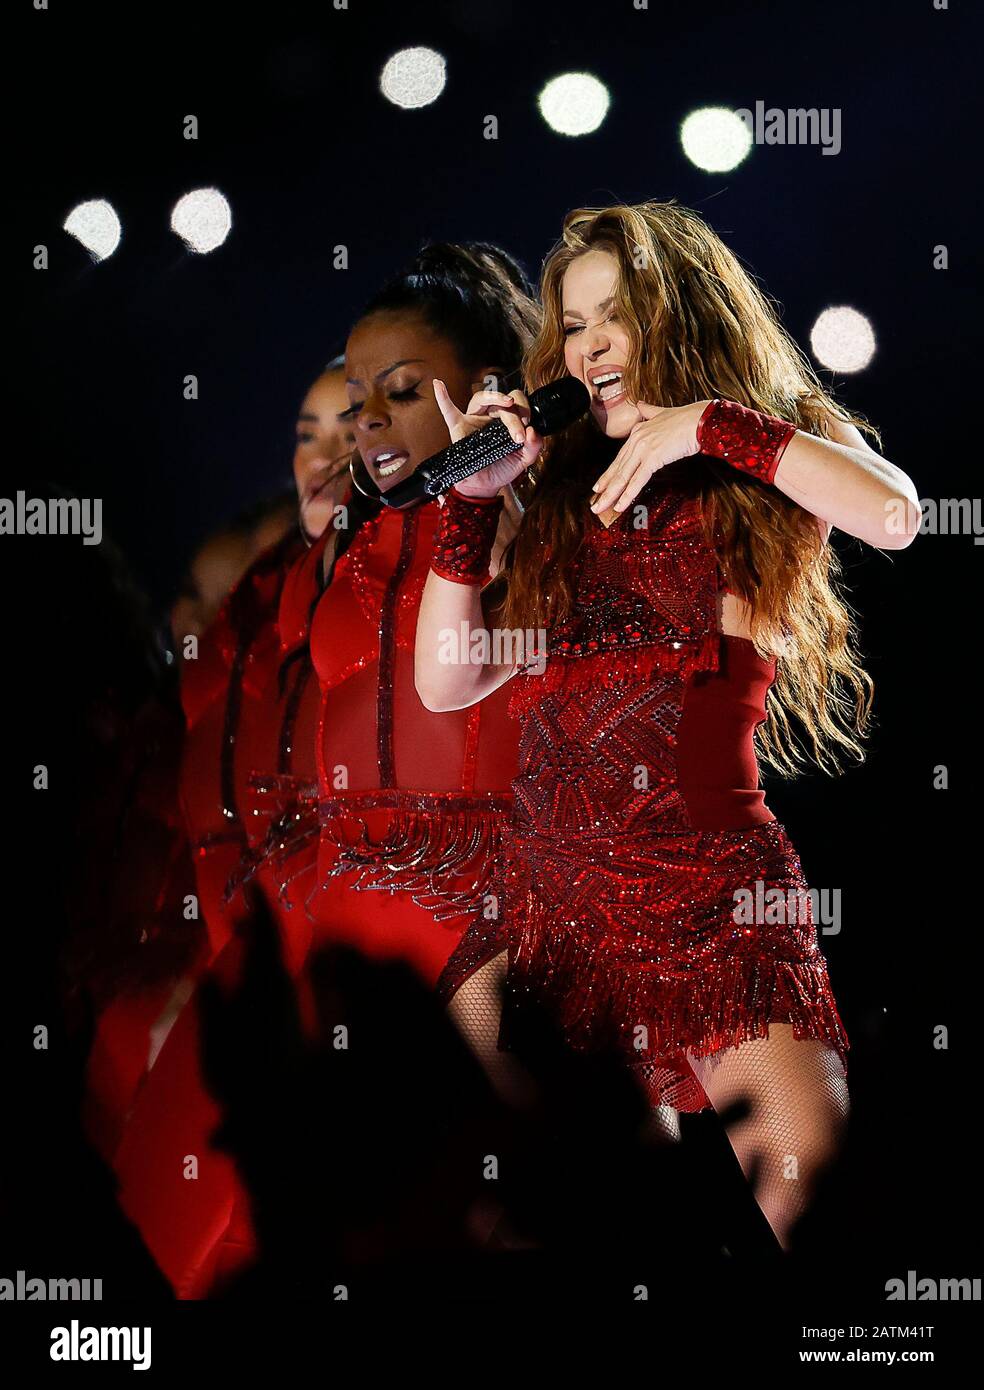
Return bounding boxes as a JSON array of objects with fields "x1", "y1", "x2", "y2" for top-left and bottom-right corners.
[{"x1": 319, "y1": 808, "x2": 510, "y2": 922}]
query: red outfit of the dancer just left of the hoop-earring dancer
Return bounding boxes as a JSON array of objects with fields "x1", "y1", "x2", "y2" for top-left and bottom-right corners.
[{"x1": 114, "y1": 534, "x2": 307, "y2": 1298}]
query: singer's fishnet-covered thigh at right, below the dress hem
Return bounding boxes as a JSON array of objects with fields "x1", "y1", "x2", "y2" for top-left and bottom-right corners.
[{"x1": 687, "y1": 1023, "x2": 849, "y2": 1250}]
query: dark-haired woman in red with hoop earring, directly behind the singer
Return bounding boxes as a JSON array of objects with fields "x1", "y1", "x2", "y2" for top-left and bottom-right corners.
[{"x1": 269, "y1": 243, "x2": 538, "y2": 984}]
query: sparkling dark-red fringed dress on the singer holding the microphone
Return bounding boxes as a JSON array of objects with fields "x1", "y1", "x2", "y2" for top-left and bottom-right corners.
[{"x1": 438, "y1": 460, "x2": 849, "y2": 1111}]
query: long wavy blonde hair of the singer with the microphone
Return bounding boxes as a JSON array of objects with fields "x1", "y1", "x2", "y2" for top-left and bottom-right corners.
[{"x1": 489, "y1": 200, "x2": 878, "y2": 777}]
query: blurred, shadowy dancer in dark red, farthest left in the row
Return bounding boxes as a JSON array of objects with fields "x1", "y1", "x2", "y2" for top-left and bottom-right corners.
[{"x1": 83, "y1": 496, "x2": 303, "y2": 1162}]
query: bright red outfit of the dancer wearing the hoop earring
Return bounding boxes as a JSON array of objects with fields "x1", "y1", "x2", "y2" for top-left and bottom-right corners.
[{"x1": 281, "y1": 502, "x2": 518, "y2": 986}]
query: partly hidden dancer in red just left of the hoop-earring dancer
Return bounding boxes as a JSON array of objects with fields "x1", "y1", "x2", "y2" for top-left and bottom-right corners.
[{"x1": 114, "y1": 363, "x2": 356, "y2": 1298}]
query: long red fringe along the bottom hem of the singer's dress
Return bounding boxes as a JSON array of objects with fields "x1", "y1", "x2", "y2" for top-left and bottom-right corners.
[{"x1": 503, "y1": 894, "x2": 851, "y2": 1068}]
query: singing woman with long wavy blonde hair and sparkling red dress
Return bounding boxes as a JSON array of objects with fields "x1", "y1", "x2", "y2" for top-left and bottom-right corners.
[{"x1": 416, "y1": 202, "x2": 920, "y2": 1248}]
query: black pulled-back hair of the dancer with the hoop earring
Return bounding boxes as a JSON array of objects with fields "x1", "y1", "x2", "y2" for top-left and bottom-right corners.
[{"x1": 360, "y1": 242, "x2": 539, "y2": 384}]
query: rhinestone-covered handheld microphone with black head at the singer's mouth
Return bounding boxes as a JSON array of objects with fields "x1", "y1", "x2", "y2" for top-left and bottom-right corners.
[{"x1": 379, "y1": 377, "x2": 591, "y2": 507}]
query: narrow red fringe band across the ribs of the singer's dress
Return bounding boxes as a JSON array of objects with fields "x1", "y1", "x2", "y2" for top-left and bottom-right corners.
[{"x1": 509, "y1": 631, "x2": 721, "y2": 719}]
